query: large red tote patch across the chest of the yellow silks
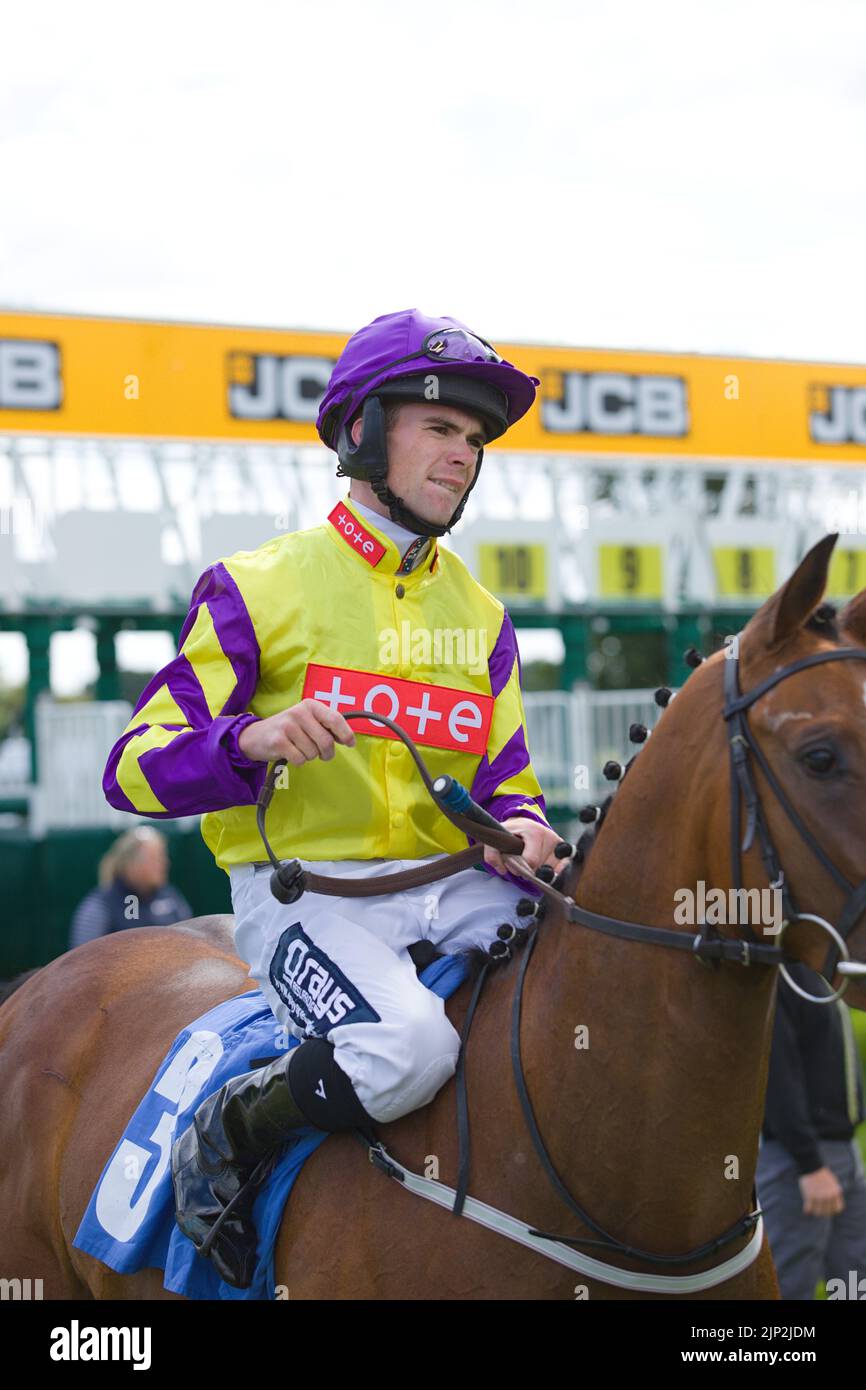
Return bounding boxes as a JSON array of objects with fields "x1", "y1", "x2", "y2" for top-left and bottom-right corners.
[{"x1": 302, "y1": 662, "x2": 493, "y2": 756}]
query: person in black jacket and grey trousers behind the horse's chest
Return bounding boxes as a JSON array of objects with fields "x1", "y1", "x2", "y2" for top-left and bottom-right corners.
[{"x1": 758, "y1": 965, "x2": 866, "y2": 1298}]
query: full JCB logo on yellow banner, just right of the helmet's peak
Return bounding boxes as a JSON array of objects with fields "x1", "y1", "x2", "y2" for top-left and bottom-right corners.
[{"x1": 541, "y1": 371, "x2": 688, "y2": 438}]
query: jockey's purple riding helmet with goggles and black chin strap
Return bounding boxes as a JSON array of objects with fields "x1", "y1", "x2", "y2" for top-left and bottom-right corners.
[{"x1": 316, "y1": 309, "x2": 541, "y2": 535}]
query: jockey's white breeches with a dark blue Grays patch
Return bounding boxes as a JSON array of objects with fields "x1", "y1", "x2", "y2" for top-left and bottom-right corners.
[{"x1": 231, "y1": 855, "x2": 527, "y2": 1123}]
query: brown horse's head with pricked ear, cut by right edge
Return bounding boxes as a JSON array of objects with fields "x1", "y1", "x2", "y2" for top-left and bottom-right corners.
[{"x1": 724, "y1": 535, "x2": 866, "y2": 1008}]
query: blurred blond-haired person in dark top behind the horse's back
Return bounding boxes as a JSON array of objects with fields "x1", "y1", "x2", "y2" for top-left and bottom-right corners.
[{"x1": 70, "y1": 826, "x2": 193, "y2": 948}]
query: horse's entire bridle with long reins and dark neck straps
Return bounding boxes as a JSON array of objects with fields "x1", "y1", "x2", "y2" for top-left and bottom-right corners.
[{"x1": 257, "y1": 637, "x2": 866, "y2": 1283}]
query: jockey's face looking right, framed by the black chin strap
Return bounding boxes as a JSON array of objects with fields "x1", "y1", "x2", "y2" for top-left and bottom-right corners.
[{"x1": 352, "y1": 400, "x2": 485, "y2": 525}]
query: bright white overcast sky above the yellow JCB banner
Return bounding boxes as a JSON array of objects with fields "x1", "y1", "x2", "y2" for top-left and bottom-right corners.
[{"x1": 0, "y1": 0, "x2": 866, "y2": 361}]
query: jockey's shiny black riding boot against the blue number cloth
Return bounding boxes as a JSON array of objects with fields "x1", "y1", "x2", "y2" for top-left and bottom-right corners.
[{"x1": 171, "y1": 1038, "x2": 370, "y2": 1289}]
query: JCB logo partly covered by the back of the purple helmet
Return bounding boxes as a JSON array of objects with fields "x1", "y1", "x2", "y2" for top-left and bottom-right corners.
[{"x1": 228, "y1": 352, "x2": 334, "y2": 421}]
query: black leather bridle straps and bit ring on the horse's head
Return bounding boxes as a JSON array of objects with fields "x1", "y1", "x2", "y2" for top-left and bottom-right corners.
[{"x1": 721, "y1": 635, "x2": 866, "y2": 1004}]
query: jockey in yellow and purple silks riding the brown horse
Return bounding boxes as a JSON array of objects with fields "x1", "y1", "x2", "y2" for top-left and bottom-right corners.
[{"x1": 104, "y1": 310, "x2": 562, "y2": 1287}]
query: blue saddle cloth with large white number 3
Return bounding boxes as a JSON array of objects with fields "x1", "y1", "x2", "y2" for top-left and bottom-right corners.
[{"x1": 72, "y1": 955, "x2": 468, "y2": 1298}]
